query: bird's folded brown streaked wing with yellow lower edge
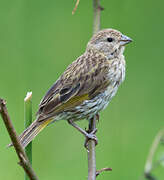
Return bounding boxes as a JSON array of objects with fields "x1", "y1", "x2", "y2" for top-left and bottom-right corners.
[{"x1": 38, "y1": 53, "x2": 110, "y2": 120}]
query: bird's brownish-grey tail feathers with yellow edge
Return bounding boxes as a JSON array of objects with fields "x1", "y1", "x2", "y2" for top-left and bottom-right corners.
[{"x1": 8, "y1": 119, "x2": 52, "y2": 148}]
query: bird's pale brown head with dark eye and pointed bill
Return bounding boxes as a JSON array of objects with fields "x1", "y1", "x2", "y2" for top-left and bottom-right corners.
[{"x1": 87, "y1": 29, "x2": 132, "y2": 59}]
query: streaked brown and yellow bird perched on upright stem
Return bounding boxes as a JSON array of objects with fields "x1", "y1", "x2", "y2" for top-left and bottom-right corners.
[{"x1": 10, "y1": 28, "x2": 132, "y2": 148}]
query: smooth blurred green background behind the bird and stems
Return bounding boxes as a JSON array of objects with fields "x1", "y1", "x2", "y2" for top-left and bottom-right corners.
[{"x1": 0, "y1": 0, "x2": 164, "y2": 180}]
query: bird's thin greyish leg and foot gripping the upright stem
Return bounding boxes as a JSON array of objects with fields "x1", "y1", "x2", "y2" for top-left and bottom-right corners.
[{"x1": 68, "y1": 120, "x2": 98, "y2": 148}]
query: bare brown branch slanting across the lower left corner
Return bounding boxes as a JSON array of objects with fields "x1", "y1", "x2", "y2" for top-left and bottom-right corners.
[{"x1": 0, "y1": 99, "x2": 38, "y2": 180}]
